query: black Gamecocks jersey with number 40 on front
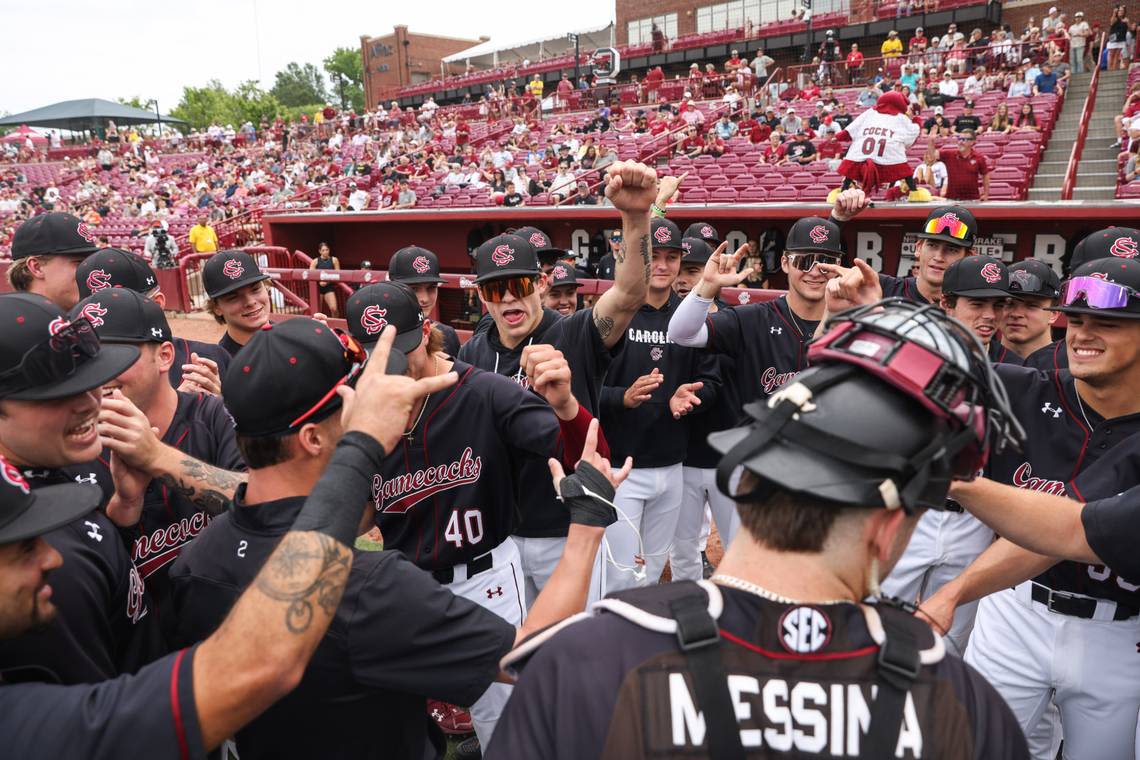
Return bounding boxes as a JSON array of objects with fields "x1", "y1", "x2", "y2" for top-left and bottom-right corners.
[{"x1": 372, "y1": 361, "x2": 562, "y2": 570}]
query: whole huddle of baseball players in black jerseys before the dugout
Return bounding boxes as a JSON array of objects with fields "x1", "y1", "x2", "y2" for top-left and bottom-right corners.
[{"x1": 0, "y1": 162, "x2": 1140, "y2": 760}]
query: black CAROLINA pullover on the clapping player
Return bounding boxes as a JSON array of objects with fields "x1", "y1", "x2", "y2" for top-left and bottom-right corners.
[{"x1": 601, "y1": 293, "x2": 720, "y2": 467}]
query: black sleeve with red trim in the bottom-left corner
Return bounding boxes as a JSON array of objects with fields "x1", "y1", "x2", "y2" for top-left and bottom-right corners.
[{"x1": 0, "y1": 649, "x2": 206, "y2": 760}]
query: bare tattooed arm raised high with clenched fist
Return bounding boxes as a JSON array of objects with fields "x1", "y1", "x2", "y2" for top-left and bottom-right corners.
[{"x1": 594, "y1": 161, "x2": 657, "y2": 348}]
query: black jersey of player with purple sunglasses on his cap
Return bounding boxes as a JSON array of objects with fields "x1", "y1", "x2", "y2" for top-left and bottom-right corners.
[{"x1": 987, "y1": 365, "x2": 1140, "y2": 610}]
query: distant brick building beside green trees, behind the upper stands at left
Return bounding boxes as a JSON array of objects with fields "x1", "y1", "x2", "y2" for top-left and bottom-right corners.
[{"x1": 360, "y1": 25, "x2": 489, "y2": 109}]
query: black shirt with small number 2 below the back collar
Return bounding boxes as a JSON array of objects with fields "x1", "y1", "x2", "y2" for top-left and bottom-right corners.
[{"x1": 169, "y1": 487, "x2": 515, "y2": 760}]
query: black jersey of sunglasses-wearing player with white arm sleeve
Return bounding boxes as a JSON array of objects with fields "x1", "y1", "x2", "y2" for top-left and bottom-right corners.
[{"x1": 705, "y1": 296, "x2": 819, "y2": 417}]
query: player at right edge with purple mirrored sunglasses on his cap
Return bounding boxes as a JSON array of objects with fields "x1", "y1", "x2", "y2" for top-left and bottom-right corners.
[{"x1": 923, "y1": 258, "x2": 1140, "y2": 758}]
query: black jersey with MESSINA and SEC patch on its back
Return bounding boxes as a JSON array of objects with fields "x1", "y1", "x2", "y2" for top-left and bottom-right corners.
[{"x1": 485, "y1": 588, "x2": 1028, "y2": 760}]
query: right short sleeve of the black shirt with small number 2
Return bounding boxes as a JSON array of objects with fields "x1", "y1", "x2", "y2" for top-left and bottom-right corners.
[{"x1": 341, "y1": 551, "x2": 515, "y2": 704}]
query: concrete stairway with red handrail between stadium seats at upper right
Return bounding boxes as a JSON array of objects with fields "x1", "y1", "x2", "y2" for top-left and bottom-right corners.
[{"x1": 1029, "y1": 71, "x2": 1127, "y2": 201}]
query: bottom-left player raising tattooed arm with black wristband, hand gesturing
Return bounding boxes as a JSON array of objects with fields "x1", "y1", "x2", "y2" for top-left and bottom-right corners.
[{"x1": 0, "y1": 328, "x2": 454, "y2": 760}]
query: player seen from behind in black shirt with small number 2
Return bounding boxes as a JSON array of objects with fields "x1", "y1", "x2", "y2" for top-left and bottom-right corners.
[{"x1": 164, "y1": 316, "x2": 620, "y2": 758}]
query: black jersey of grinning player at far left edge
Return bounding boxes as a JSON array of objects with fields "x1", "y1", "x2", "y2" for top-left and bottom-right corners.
[{"x1": 0, "y1": 466, "x2": 164, "y2": 684}]
